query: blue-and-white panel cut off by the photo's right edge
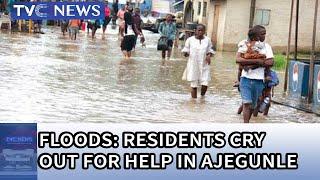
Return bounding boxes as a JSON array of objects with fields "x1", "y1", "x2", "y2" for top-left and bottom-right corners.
[{"x1": 312, "y1": 64, "x2": 320, "y2": 112}]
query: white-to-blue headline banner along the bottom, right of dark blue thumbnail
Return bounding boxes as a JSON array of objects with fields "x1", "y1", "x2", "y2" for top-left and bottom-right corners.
[{"x1": 37, "y1": 124, "x2": 320, "y2": 180}]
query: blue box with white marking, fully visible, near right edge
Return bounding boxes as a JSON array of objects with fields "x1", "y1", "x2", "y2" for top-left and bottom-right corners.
[{"x1": 289, "y1": 60, "x2": 309, "y2": 98}]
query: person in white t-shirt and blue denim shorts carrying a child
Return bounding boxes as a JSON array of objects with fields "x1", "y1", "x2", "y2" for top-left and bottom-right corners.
[{"x1": 236, "y1": 25, "x2": 273, "y2": 123}]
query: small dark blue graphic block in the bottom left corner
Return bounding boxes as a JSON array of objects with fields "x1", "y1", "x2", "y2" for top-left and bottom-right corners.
[{"x1": 0, "y1": 124, "x2": 37, "y2": 180}]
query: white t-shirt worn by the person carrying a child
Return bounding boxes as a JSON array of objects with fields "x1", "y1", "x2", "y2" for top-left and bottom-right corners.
[{"x1": 238, "y1": 40, "x2": 273, "y2": 80}]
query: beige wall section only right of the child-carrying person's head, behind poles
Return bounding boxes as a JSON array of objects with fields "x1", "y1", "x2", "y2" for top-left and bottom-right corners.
[{"x1": 256, "y1": 0, "x2": 320, "y2": 52}]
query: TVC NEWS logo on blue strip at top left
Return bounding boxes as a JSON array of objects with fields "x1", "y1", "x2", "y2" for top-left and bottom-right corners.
[{"x1": 11, "y1": 2, "x2": 105, "y2": 20}]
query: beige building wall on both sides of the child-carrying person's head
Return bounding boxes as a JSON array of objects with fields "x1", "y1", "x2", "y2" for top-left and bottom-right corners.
[{"x1": 223, "y1": 0, "x2": 320, "y2": 52}]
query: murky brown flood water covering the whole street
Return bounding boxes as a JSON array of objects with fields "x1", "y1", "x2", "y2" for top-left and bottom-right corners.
[{"x1": 0, "y1": 28, "x2": 320, "y2": 123}]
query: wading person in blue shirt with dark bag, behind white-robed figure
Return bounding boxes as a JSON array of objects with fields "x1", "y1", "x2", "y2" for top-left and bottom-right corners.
[{"x1": 159, "y1": 14, "x2": 177, "y2": 60}]
